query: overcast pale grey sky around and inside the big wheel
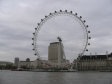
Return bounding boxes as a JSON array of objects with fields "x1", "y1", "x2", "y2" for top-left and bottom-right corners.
[{"x1": 0, "y1": 0, "x2": 112, "y2": 62}]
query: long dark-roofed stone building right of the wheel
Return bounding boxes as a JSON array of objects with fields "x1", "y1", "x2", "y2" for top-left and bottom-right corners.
[{"x1": 74, "y1": 53, "x2": 112, "y2": 71}]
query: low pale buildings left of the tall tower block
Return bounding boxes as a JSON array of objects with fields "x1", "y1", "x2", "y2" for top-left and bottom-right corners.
[{"x1": 14, "y1": 57, "x2": 51, "y2": 69}]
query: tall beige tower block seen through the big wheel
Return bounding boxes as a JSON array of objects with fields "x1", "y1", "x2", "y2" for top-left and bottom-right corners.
[{"x1": 48, "y1": 37, "x2": 70, "y2": 68}]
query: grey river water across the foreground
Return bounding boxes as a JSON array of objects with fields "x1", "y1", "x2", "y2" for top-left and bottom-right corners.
[{"x1": 0, "y1": 71, "x2": 112, "y2": 84}]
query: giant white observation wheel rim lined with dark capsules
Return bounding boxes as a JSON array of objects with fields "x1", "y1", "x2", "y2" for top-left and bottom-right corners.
[{"x1": 32, "y1": 10, "x2": 91, "y2": 58}]
